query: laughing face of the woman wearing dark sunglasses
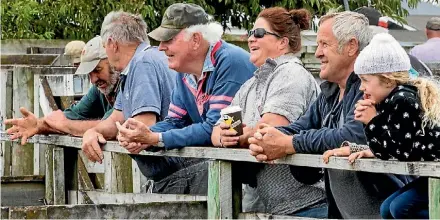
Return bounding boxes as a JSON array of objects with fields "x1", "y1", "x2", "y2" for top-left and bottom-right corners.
[{"x1": 248, "y1": 17, "x2": 288, "y2": 67}]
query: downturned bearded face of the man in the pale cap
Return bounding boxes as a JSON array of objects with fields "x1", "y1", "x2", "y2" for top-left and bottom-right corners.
[{"x1": 89, "y1": 59, "x2": 119, "y2": 95}]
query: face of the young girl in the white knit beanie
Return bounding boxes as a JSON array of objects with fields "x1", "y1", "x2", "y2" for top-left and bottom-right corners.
[{"x1": 359, "y1": 74, "x2": 396, "y2": 104}]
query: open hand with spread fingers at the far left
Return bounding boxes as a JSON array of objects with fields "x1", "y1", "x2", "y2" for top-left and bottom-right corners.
[{"x1": 5, "y1": 107, "x2": 39, "y2": 145}]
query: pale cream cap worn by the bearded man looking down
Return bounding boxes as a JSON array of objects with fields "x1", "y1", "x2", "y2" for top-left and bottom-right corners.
[{"x1": 75, "y1": 36, "x2": 107, "y2": 74}]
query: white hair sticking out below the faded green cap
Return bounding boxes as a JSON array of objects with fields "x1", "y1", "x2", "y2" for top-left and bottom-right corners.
[{"x1": 185, "y1": 22, "x2": 223, "y2": 44}]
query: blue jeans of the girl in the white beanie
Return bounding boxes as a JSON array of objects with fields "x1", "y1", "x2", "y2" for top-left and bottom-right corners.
[{"x1": 380, "y1": 177, "x2": 429, "y2": 219}]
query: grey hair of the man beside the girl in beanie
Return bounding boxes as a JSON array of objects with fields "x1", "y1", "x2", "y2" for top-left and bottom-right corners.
[{"x1": 319, "y1": 11, "x2": 373, "y2": 52}]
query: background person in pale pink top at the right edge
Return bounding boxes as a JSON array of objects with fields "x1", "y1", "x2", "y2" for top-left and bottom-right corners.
[{"x1": 409, "y1": 17, "x2": 440, "y2": 63}]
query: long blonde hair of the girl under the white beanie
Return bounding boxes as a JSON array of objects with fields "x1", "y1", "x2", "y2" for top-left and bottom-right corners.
[{"x1": 378, "y1": 71, "x2": 440, "y2": 128}]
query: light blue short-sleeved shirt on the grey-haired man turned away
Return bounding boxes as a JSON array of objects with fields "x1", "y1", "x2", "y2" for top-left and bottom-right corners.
[{"x1": 114, "y1": 43, "x2": 177, "y2": 120}]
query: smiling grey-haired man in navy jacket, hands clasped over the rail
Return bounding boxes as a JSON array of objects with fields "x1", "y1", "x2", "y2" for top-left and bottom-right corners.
[{"x1": 249, "y1": 12, "x2": 410, "y2": 218}]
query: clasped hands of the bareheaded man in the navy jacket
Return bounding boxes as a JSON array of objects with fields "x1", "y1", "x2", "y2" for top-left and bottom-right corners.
[{"x1": 249, "y1": 124, "x2": 295, "y2": 161}]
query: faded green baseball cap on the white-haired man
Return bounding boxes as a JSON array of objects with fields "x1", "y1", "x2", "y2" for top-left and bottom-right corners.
[{"x1": 148, "y1": 3, "x2": 209, "y2": 41}]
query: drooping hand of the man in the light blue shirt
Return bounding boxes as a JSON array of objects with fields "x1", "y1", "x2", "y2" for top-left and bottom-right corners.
[{"x1": 82, "y1": 128, "x2": 107, "y2": 163}]
